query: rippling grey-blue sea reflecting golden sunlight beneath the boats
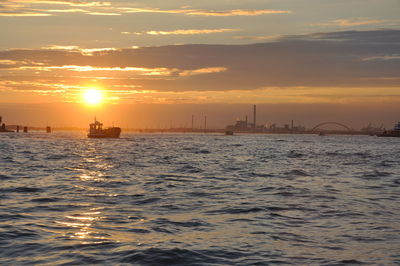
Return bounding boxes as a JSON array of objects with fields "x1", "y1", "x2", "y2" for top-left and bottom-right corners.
[{"x1": 0, "y1": 132, "x2": 400, "y2": 265}]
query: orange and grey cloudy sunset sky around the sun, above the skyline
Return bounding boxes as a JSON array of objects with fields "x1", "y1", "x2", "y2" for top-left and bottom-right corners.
[{"x1": 0, "y1": 0, "x2": 400, "y2": 127}]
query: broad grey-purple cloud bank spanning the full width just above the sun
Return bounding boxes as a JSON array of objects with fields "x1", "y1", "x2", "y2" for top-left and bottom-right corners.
[{"x1": 0, "y1": 30, "x2": 400, "y2": 100}]
